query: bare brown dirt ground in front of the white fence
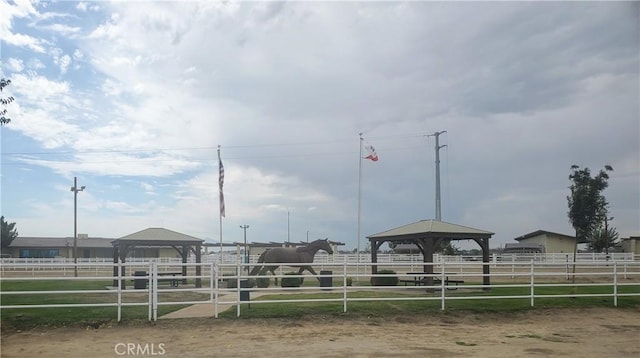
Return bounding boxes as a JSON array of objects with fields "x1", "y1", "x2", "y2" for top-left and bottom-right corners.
[{"x1": 1, "y1": 308, "x2": 640, "y2": 358}]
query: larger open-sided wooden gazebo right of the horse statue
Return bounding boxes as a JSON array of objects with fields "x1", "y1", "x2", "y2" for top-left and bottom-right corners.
[{"x1": 367, "y1": 220, "x2": 494, "y2": 286}]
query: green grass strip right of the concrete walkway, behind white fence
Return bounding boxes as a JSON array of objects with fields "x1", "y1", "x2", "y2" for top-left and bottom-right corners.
[{"x1": 219, "y1": 285, "x2": 640, "y2": 318}]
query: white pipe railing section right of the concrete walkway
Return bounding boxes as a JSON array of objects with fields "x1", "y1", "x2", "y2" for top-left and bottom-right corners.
[{"x1": 215, "y1": 260, "x2": 640, "y2": 317}]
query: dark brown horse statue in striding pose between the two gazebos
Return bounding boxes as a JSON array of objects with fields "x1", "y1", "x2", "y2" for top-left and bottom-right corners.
[{"x1": 249, "y1": 239, "x2": 333, "y2": 285}]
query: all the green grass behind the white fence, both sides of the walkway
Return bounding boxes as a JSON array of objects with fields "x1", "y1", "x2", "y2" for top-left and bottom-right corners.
[{"x1": 0, "y1": 279, "x2": 640, "y2": 330}]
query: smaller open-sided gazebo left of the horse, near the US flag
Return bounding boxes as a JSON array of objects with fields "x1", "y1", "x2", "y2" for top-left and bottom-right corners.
[{"x1": 111, "y1": 228, "x2": 204, "y2": 288}]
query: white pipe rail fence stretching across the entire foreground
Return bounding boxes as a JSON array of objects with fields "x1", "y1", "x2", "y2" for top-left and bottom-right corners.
[{"x1": 0, "y1": 258, "x2": 640, "y2": 321}]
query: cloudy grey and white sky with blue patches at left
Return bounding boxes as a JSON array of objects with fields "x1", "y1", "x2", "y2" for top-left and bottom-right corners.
[{"x1": 0, "y1": 0, "x2": 640, "y2": 250}]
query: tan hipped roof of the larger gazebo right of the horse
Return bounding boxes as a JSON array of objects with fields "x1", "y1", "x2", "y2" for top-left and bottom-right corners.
[{"x1": 367, "y1": 219, "x2": 494, "y2": 241}]
